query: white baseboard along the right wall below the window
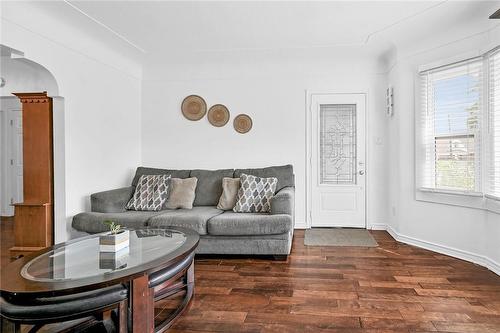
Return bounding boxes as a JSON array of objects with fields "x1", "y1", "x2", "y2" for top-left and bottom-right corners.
[{"x1": 372, "y1": 224, "x2": 500, "y2": 275}]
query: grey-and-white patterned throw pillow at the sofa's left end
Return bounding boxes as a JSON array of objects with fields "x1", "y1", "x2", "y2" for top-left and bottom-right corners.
[{"x1": 125, "y1": 175, "x2": 170, "y2": 210}]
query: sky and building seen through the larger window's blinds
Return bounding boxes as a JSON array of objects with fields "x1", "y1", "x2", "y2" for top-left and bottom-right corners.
[{"x1": 432, "y1": 64, "x2": 482, "y2": 191}]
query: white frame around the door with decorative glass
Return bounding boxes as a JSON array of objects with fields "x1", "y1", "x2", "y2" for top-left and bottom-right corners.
[{"x1": 305, "y1": 90, "x2": 369, "y2": 229}]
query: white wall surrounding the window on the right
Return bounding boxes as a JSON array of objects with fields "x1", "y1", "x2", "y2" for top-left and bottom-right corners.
[{"x1": 388, "y1": 23, "x2": 500, "y2": 273}]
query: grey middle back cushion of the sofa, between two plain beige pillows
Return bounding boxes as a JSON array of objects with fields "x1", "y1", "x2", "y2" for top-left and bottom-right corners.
[{"x1": 190, "y1": 169, "x2": 234, "y2": 206}]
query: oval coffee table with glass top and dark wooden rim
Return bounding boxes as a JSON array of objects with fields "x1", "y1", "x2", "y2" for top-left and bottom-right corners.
[{"x1": 1, "y1": 227, "x2": 199, "y2": 332}]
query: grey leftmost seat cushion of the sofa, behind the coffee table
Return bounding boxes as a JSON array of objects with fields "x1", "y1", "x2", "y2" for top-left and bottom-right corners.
[{"x1": 72, "y1": 210, "x2": 161, "y2": 234}]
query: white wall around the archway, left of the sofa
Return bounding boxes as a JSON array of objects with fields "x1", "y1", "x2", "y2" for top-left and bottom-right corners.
[{"x1": 1, "y1": 2, "x2": 142, "y2": 242}]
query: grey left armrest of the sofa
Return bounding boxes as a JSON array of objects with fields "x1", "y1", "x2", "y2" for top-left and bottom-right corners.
[{"x1": 90, "y1": 186, "x2": 135, "y2": 213}]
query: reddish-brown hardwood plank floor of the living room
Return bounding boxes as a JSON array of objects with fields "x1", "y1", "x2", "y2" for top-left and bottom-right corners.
[{"x1": 1, "y1": 217, "x2": 500, "y2": 333}]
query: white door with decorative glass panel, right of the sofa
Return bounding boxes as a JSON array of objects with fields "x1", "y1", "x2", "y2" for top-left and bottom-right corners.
[{"x1": 310, "y1": 94, "x2": 366, "y2": 228}]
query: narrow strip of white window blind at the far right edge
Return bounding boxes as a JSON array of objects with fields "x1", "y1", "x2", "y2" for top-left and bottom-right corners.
[{"x1": 486, "y1": 49, "x2": 500, "y2": 198}]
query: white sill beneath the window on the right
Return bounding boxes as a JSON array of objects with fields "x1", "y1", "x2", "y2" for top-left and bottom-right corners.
[{"x1": 415, "y1": 188, "x2": 500, "y2": 214}]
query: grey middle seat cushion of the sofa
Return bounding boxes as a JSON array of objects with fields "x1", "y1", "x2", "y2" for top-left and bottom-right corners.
[{"x1": 147, "y1": 206, "x2": 222, "y2": 235}]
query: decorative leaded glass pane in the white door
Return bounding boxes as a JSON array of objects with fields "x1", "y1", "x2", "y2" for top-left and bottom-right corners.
[{"x1": 320, "y1": 104, "x2": 356, "y2": 184}]
